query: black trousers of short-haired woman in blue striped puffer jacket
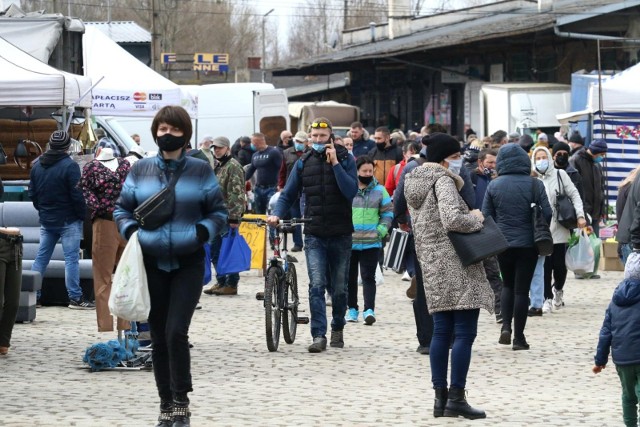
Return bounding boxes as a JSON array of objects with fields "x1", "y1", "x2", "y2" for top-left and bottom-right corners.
[{"x1": 144, "y1": 250, "x2": 204, "y2": 400}]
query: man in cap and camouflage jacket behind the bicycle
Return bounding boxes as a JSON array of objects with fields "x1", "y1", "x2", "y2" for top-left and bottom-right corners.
[{"x1": 204, "y1": 136, "x2": 246, "y2": 295}]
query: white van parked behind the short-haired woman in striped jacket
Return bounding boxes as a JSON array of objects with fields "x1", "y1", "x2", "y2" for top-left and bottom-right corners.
[{"x1": 110, "y1": 83, "x2": 290, "y2": 151}]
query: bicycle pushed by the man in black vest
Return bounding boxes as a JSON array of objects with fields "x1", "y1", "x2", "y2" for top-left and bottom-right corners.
[{"x1": 242, "y1": 218, "x2": 311, "y2": 351}]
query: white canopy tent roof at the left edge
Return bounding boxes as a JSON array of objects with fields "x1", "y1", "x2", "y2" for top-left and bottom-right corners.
[{"x1": 0, "y1": 37, "x2": 91, "y2": 108}]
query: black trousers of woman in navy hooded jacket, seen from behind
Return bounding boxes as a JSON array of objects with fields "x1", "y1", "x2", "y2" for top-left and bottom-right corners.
[{"x1": 498, "y1": 247, "x2": 538, "y2": 339}]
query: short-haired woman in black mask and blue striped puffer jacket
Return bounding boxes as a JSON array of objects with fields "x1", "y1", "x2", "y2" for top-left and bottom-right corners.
[{"x1": 113, "y1": 106, "x2": 227, "y2": 427}]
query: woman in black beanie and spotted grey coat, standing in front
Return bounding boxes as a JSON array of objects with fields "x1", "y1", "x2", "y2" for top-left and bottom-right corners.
[{"x1": 404, "y1": 133, "x2": 494, "y2": 419}]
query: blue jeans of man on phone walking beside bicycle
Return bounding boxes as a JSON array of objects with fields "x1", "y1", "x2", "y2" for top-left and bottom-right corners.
[{"x1": 304, "y1": 234, "x2": 351, "y2": 338}]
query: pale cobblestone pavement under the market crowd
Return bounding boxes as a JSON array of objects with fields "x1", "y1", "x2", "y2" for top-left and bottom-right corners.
[{"x1": 0, "y1": 252, "x2": 622, "y2": 427}]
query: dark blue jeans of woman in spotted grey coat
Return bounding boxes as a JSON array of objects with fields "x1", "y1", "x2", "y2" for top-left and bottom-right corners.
[{"x1": 429, "y1": 309, "x2": 480, "y2": 388}]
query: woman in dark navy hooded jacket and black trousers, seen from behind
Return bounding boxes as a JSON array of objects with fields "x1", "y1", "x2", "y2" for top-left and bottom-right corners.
[{"x1": 482, "y1": 143, "x2": 552, "y2": 350}]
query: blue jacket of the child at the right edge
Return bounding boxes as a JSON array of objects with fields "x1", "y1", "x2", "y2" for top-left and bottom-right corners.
[{"x1": 595, "y1": 279, "x2": 640, "y2": 366}]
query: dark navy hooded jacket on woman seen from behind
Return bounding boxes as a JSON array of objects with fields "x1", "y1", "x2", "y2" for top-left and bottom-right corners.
[{"x1": 482, "y1": 143, "x2": 553, "y2": 248}]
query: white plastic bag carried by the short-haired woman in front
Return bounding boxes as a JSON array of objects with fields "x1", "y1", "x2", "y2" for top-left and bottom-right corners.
[{"x1": 109, "y1": 231, "x2": 151, "y2": 322}]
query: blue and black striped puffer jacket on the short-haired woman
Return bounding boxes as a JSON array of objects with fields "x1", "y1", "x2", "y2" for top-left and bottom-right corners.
[{"x1": 113, "y1": 152, "x2": 227, "y2": 271}]
